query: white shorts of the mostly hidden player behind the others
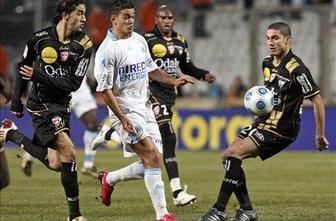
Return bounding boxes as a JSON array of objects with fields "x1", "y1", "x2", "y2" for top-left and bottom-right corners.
[{"x1": 71, "y1": 78, "x2": 97, "y2": 118}]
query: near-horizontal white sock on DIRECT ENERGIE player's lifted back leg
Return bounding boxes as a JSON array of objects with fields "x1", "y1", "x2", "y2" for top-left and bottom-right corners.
[{"x1": 106, "y1": 161, "x2": 145, "y2": 185}]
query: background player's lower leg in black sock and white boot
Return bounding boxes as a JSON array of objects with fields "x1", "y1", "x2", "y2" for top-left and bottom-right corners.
[{"x1": 160, "y1": 122, "x2": 196, "y2": 206}]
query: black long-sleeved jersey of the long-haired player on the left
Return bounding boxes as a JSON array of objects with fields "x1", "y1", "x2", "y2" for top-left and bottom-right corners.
[{"x1": 12, "y1": 26, "x2": 92, "y2": 109}]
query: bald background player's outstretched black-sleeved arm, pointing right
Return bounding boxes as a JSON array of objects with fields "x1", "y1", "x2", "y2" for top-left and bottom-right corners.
[{"x1": 180, "y1": 41, "x2": 216, "y2": 83}]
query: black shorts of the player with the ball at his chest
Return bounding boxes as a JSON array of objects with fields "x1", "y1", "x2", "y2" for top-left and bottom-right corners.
[{"x1": 238, "y1": 126, "x2": 294, "y2": 160}]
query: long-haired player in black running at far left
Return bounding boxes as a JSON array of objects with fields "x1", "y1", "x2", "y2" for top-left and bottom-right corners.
[{"x1": 0, "y1": 0, "x2": 92, "y2": 221}]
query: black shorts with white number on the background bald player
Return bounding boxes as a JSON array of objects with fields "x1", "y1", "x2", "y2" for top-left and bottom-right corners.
[{"x1": 149, "y1": 95, "x2": 173, "y2": 126}]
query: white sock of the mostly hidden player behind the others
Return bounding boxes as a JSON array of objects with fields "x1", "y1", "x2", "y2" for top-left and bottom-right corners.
[{"x1": 83, "y1": 130, "x2": 97, "y2": 168}]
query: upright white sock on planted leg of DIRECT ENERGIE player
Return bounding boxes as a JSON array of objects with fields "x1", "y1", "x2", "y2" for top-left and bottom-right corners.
[{"x1": 145, "y1": 168, "x2": 168, "y2": 219}]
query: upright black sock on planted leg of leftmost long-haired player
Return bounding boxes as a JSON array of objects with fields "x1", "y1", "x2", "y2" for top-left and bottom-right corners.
[{"x1": 61, "y1": 161, "x2": 81, "y2": 220}]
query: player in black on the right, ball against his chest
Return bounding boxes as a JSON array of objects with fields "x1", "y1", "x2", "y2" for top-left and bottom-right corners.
[{"x1": 199, "y1": 22, "x2": 329, "y2": 221}]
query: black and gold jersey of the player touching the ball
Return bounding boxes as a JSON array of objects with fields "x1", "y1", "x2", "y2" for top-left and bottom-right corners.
[{"x1": 254, "y1": 51, "x2": 320, "y2": 139}]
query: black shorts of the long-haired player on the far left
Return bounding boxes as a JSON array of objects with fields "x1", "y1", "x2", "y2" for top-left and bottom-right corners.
[{"x1": 29, "y1": 105, "x2": 70, "y2": 147}]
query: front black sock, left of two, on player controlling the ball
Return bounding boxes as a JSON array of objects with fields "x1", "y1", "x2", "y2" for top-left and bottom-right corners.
[{"x1": 213, "y1": 157, "x2": 242, "y2": 212}]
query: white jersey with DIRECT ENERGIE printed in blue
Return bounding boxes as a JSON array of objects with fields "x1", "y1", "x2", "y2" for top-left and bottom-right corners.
[{"x1": 94, "y1": 29, "x2": 158, "y2": 115}]
